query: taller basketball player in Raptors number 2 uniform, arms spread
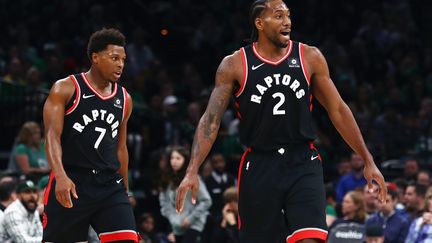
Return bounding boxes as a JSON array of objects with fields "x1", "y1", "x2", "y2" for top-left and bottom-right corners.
[{"x1": 176, "y1": 0, "x2": 386, "y2": 243}]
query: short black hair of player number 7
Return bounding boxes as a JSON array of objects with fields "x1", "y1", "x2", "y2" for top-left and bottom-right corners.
[{"x1": 87, "y1": 28, "x2": 126, "y2": 61}]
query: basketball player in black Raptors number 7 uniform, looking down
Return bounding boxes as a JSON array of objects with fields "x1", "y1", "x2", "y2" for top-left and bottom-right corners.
[{"x1": 43, "y1": 29, "x2": 138, "y2": 242}]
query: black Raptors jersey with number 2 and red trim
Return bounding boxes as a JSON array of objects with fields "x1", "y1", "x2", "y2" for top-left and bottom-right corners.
[{"x1": 235, "y1": 41, "x2": 316, "y2": 150}]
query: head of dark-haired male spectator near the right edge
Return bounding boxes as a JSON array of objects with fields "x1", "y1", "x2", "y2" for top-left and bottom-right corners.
[{"x1": 404, "y1": 184, "x2": 427, "y2": 222}]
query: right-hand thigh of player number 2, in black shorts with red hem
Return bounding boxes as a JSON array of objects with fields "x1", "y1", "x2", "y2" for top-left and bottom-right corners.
[{"x1": 284, "y1": 160, "x2": 327, "y2": 242}]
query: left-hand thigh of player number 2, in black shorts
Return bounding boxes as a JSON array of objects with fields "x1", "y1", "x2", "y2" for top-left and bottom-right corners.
[{"x1": 239, "y1": 152, "x2": 283, "y2": 243}]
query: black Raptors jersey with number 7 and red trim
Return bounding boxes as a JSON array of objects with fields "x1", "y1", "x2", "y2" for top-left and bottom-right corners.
[{"x1": 61, "y1": 73, "x2": 127, "y2": 170}]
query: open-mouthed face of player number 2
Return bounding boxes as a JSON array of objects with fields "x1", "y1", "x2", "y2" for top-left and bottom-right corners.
[{"x1": 261, "y1": 0, "x2": 291, "y2": 48}]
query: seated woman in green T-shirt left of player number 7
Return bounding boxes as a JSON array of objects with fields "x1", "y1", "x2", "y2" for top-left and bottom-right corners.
[{"x1": 8, "y1": 121, "x2": 50, "y2": 182}]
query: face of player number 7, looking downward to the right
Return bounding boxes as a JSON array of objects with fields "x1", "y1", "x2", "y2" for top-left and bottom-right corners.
[{"x1": 93, "y1": 45, "x2": 126, "y2": 82}]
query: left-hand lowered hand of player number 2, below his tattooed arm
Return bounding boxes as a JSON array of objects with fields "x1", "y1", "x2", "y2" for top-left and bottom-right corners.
[{"x1": 176, "y1": 173, "x2": 199, "y2": 213}]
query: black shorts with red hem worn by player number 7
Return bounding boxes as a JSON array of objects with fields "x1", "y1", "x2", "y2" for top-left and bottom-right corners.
[{"x1": 43, "y1": 169, "x2": 138, "y2": 243}]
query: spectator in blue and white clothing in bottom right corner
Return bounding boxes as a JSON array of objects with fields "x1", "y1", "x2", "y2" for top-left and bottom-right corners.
[{"x1": 405, "y1": 194, "x2": 432, "y2": 243}]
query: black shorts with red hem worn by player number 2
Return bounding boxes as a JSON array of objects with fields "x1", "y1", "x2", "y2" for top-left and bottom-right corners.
[{"x1": 238, "y1": 144, "x2": 327, "y2": 243}]
